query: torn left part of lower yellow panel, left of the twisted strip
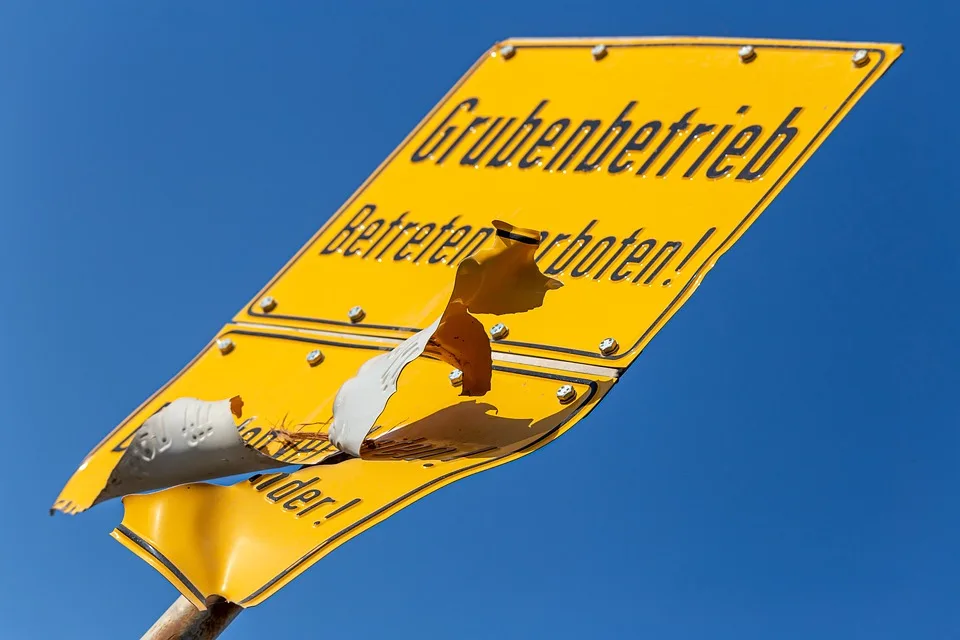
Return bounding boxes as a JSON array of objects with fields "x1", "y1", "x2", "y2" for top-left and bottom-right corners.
[{"x1": 53, "y1": 326, "x2": 390, "y2": 513}]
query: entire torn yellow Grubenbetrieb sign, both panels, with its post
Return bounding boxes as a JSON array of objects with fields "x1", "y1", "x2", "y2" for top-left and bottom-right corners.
[{"x1": 53, "y1": 38, "x2": 902, "y2": 638}]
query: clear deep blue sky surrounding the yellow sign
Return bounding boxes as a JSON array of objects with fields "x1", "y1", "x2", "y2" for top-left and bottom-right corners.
[{"x1": 0, "y1": 0, "x2": 960, "y2": 640}]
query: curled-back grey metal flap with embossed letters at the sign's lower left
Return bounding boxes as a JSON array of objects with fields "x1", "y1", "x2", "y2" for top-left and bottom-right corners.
[{"x1": 95, "y1": 396, "x2": 285, "y2": 503}]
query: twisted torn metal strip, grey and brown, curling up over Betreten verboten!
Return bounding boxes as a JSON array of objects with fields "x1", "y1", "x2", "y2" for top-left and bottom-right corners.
[{"x1": 330, "y1": 220, "x2": 563, "y2": 456}]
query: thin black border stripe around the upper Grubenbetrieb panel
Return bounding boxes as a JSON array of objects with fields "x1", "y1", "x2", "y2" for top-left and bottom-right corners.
[{"x1": 247, "y1": 38, "x2": 886, "y2": 362}]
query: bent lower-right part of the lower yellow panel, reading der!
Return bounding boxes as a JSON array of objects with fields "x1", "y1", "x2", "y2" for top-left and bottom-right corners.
[{"x1": 113, "y1": 336, "x2": 614, "y2": 607}]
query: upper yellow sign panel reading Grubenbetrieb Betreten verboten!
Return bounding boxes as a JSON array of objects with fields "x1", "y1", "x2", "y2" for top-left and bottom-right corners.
[{"x1": 236, "y1": 38, "x2": 901, "y2": 366}]
